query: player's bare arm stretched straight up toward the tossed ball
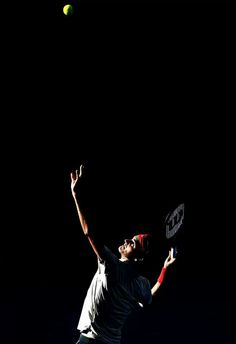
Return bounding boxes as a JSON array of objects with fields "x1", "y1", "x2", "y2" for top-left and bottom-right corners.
[{"x1": 70, "y1": 165, "x2": 102, "y2": 258}]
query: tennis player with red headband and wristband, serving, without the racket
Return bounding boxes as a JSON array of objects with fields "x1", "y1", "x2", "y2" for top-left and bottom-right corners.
[{"x1": 71, "y1": 165, "x2": 176, "y2": 344}]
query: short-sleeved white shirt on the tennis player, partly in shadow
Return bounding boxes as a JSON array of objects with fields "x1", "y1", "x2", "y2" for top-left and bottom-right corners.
[{"x1": 78, "y1": 246, "x2": 152, "y2": 344}]
